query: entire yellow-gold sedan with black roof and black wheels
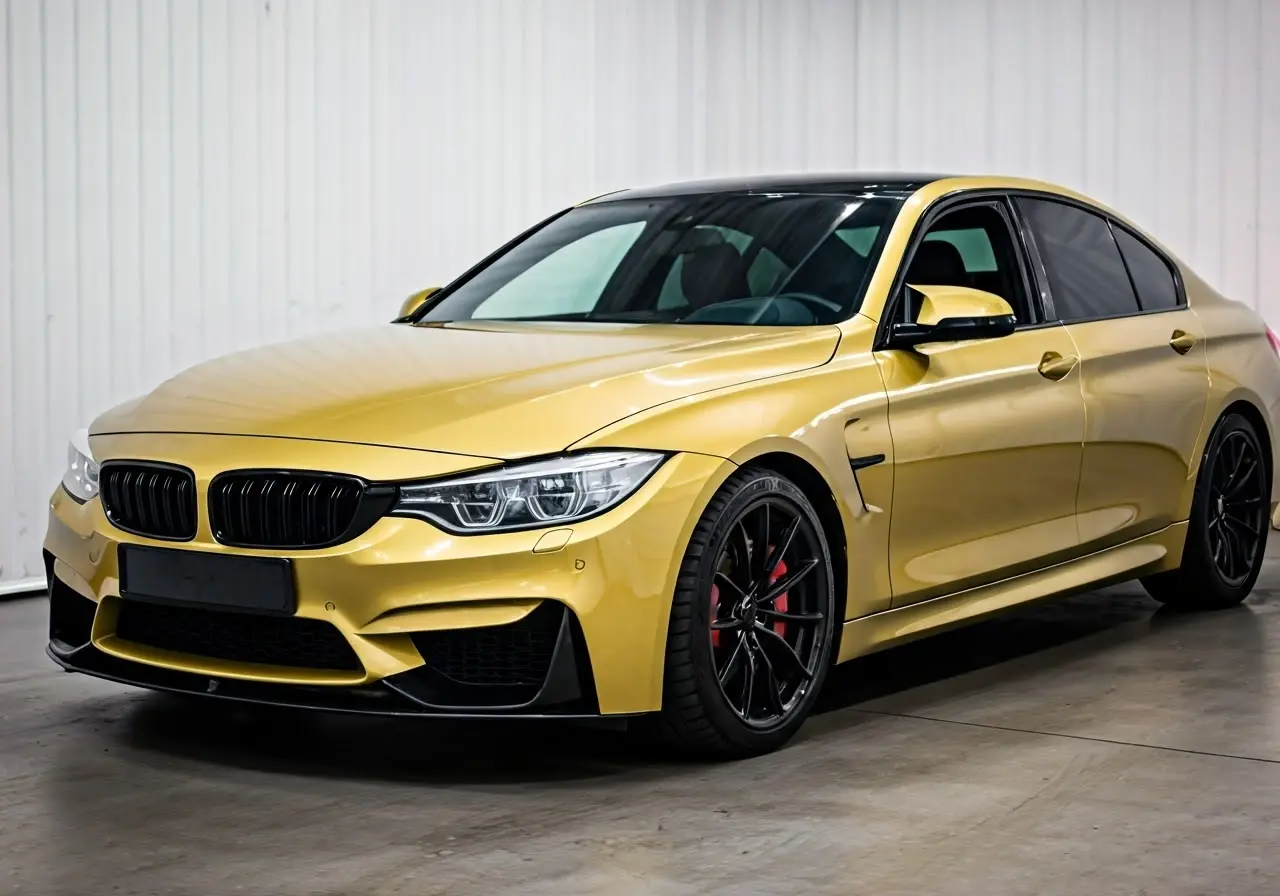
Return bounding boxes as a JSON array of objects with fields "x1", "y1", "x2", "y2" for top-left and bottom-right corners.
[{"x1": 45, "y1": 174, "x2": 1280, "y2": 756}]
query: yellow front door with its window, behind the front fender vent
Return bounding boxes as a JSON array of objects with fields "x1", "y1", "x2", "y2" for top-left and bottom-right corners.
[{"x1": 877, "y1": 197, "x2": 1084, "y2": 607}]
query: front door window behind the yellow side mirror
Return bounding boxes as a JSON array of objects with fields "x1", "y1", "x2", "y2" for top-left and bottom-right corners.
[{"x1": 899, "y1": 202, "x2": 1034, "y2": 324}]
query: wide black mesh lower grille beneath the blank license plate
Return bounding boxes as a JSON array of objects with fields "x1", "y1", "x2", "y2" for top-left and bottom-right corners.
[{"x1": 115, "y1": 600, "x2": 362, "y2": 672}]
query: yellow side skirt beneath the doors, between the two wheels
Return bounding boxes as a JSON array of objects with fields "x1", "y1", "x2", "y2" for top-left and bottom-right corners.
[{"x1": 836, "y1": 522, "x2": 1187, "y2": 663}]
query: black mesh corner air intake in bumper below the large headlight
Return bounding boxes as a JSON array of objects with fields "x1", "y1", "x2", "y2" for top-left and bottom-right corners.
[{"x1": 411, "y1": 600, "x2": 564, "y2": 685}]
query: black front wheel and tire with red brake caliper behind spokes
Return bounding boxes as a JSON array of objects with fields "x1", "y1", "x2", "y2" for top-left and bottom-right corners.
[{"x1": 652, "y1": 470, "x2": 837, "y2": 759}]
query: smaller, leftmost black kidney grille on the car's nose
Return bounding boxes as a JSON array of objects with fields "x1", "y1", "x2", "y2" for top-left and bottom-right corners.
[{"x1": 99, "y1": 461, "x2": 196, "y2": 541}]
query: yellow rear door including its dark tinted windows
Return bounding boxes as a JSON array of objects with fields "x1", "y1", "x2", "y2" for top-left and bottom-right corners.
[{"x1": 1018, "y1": 196, "x2": 1210, "y2": 550}]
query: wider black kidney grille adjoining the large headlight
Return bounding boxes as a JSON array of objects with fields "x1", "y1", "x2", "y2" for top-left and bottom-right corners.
[{"x1": 209, "y1": 471, "x2": 385, "y2": 548}]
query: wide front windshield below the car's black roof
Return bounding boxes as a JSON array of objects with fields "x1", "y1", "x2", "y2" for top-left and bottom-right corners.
[{"x1": 416, "y1": 193, "x2": 902, "y2": 326}]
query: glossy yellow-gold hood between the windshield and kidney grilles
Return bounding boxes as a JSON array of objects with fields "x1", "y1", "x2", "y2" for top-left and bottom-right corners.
[{"x1": 91, "y1": 323, "x2": 840, "y2": 460}]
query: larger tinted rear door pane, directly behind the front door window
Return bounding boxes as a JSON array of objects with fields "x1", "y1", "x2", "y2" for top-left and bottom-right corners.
[{"x1": 1019, "y1": 198, "x2": 1138, "y2": 320}]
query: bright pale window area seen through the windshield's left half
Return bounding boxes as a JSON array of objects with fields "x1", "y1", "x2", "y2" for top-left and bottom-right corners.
[{"x1": 472, "y1": 221, "x2": 644, "y2": 320}]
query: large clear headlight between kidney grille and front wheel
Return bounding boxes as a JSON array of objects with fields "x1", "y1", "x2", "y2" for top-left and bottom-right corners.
[{"x1": 392, "y1": 451, "x2": 663, "y2": 534}]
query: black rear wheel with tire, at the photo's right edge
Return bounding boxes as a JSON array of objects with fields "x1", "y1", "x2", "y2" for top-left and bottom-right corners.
[{"x1": 1142, "y1": 413, "x2": 1271, "y2": 611}]
